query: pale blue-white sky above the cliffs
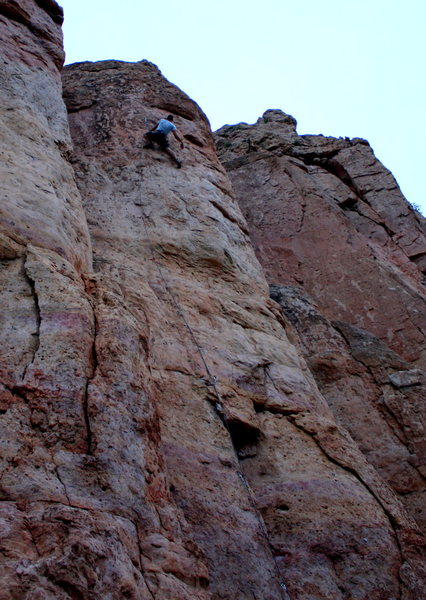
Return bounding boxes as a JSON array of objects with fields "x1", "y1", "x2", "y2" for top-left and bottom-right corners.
[{"x1": 59, "y1": 0, "x2": 426, "y2": 214}]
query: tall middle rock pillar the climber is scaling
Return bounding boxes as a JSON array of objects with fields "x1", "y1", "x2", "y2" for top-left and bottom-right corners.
[{"x1": 64, "y1": 61, "x2": 421, "y2": 600}]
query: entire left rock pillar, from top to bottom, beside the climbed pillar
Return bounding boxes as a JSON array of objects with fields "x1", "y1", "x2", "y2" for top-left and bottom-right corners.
[{"x1": 0, "y1": 0, "x2": 207, "y2": 600}]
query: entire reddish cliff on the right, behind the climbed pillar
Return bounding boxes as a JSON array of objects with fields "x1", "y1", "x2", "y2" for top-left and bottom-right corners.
[{"x1": 216, "y1": 110, "x2": 426, "y2": 527}]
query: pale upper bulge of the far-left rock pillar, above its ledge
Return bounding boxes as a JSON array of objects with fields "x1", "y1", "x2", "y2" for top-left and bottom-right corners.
[{"x1": 0, "y1": 0, "x2": 90, "y2": 271}]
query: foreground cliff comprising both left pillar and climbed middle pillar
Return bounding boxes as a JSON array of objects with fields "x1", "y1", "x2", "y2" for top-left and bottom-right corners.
[{"x1": 0, "y1": 0, "x2": 424, "y2": 600}]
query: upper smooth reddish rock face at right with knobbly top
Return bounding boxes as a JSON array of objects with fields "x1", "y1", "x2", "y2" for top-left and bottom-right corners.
[{"x1": 216, "y1": 110, "x2": 426, "y2": 366}]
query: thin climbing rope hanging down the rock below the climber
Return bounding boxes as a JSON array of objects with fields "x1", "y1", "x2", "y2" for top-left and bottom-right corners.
[{"x1": 140, "y1": 193, "x2": 291, "y2": 600}]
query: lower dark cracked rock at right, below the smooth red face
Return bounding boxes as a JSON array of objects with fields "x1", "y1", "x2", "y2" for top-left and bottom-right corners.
[{"x1": 271, "y1": 286, "x2": 426, "y2": 530}]
